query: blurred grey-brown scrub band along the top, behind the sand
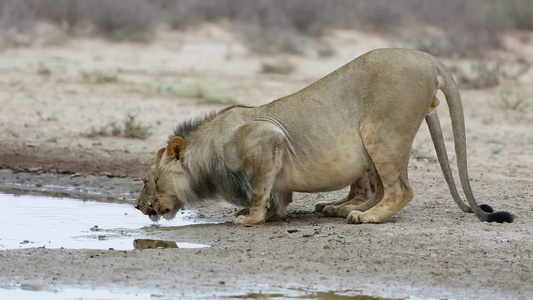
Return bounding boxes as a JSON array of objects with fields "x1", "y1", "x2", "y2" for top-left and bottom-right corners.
[{"x1": 0, "y1": 0, "x2": 533, "y2": 57}]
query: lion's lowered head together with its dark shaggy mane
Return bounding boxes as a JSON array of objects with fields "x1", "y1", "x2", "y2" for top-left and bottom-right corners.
[{"x1": 136, "y1": 109, "x2": 252, "y2": 221}]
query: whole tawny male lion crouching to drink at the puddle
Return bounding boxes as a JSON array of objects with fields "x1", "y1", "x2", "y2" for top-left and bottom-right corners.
[{"x1": 136, "y1": 49, "x2": 513, "y2": 226}]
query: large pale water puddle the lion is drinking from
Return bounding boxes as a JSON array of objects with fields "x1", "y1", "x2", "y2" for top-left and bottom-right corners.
[{"x1": 0, "y1": 194, "x2": 209, "y2": 250}]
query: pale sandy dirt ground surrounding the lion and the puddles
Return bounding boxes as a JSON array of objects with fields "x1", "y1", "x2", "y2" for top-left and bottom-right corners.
[{"x1": 0, "y1": 25, "x2": 533, "y2": 299}]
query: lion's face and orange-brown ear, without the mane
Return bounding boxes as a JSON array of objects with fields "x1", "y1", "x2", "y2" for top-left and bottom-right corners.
[{"x1": 136, "y1": 137, "x2": 196, "y2": 221}]
